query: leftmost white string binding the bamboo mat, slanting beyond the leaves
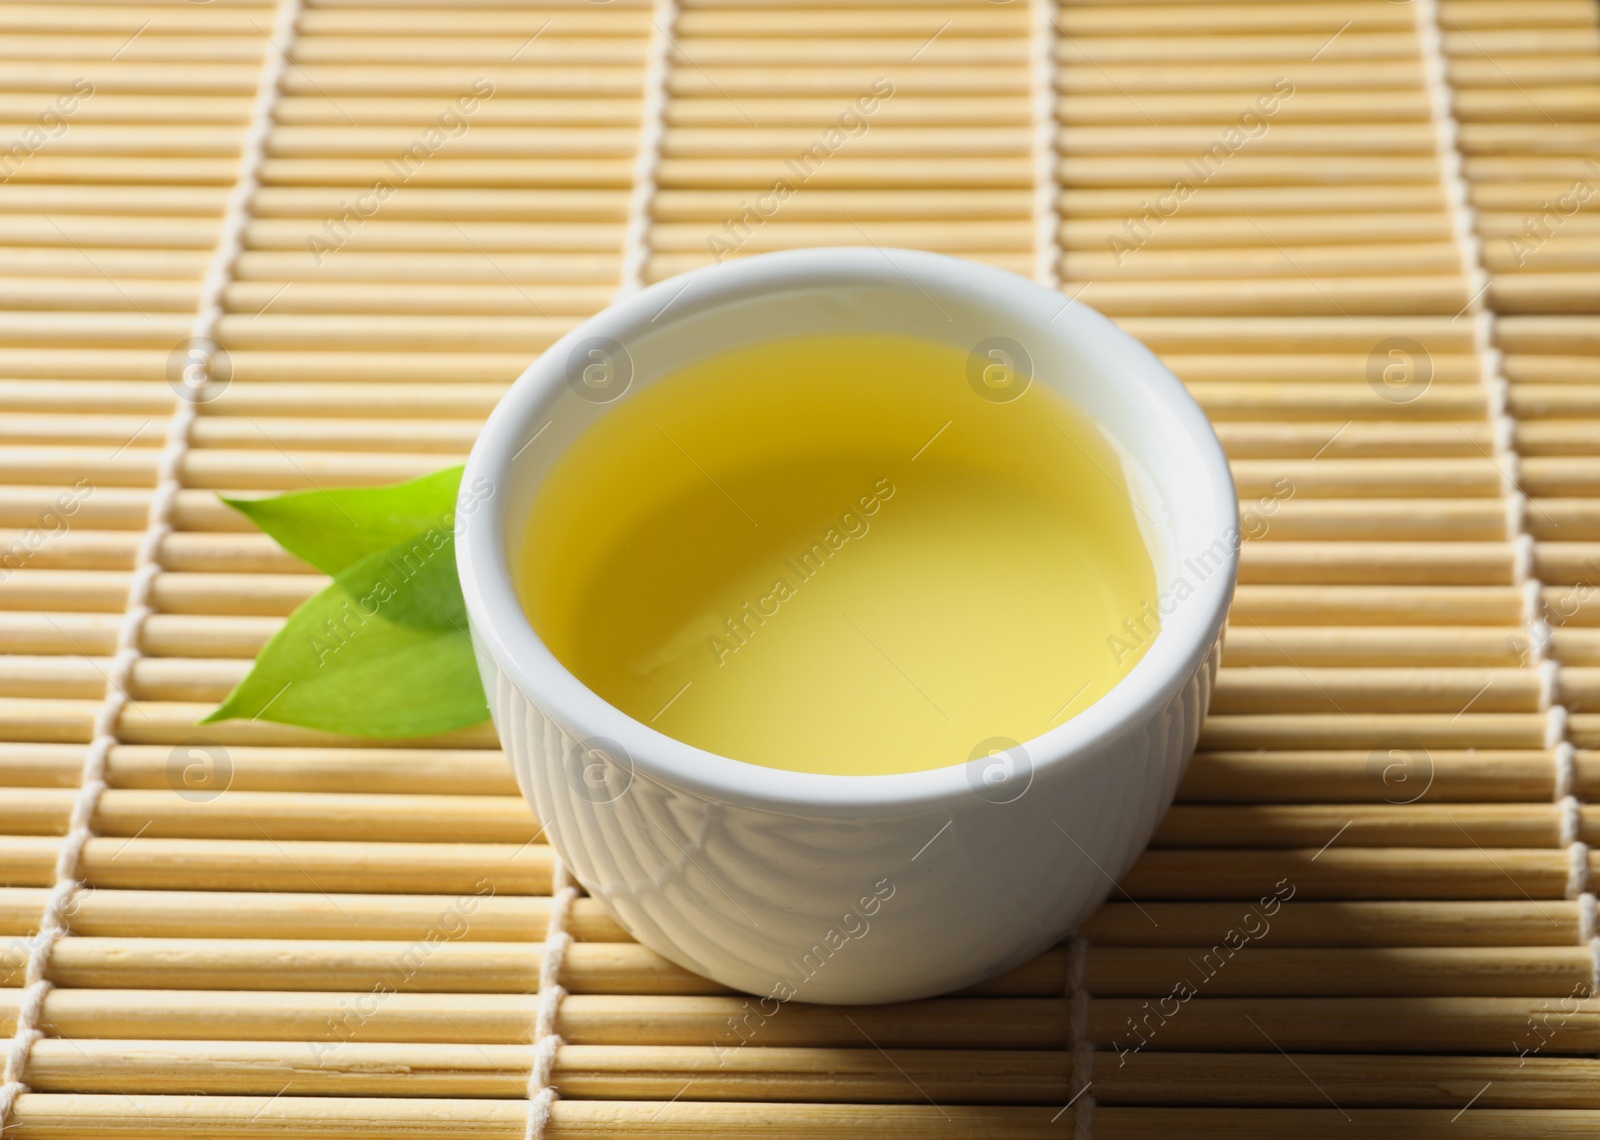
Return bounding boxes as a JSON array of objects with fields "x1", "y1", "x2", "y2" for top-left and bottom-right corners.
[{"x1": 0, "y1": 0, "x2": 301, "y2": 1132}]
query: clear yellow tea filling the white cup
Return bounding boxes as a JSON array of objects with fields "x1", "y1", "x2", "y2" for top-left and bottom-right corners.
[{"x1": 520, "y1": 336, "x2": 1157, "y2": 775}]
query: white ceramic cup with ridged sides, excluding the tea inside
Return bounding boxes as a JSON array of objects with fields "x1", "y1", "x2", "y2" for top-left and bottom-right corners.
[{"x1": 458, "y1": 248, "x2": 1238, "y2": 999}]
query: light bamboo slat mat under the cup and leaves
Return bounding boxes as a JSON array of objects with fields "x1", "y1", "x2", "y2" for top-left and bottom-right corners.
[{"x1": 0, "y1": 0, "x2": 1600, "y2": 1140}]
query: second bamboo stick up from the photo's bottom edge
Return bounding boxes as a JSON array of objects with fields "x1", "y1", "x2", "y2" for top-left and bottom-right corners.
[{"x1": 29, "y1": 1039, "x2": 1600, "y2": 1108}]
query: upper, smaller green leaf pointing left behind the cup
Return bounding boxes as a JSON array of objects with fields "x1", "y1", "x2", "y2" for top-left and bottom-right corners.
[{"x1": 222, "y1": 468, "x2": 461, "y2": 573}]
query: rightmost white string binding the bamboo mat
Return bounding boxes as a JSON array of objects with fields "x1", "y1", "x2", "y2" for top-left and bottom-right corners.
[{"x1": 1416, "y1": 0, "x2": 1600, "y2": 996}]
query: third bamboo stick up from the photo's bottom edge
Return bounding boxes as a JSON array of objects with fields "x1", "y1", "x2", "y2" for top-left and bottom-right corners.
[{"x1": 0, "y1": 986, "x2": 1600, "y2": 1057}]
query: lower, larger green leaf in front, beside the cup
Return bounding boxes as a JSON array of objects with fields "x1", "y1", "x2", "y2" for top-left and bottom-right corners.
[{"x1": 205, "y1": 528, "x2": 490, "y2": 737}]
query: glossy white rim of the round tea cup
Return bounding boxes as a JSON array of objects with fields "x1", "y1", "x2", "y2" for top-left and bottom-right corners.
[{"x1": 456, "y1": 247, "x2": 1238, "y2": 815}]
